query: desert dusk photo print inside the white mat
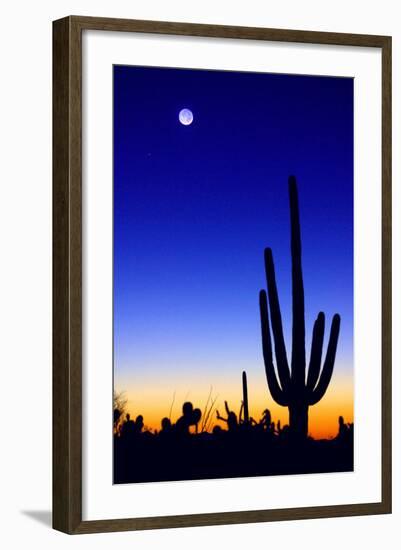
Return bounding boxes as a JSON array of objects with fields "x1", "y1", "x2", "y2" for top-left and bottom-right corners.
[{"x1": 112, "y1": 65, "x2": 354, "y2": 484}]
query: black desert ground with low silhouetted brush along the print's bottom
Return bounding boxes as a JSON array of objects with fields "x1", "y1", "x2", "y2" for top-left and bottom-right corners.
[{"x1": 114, "y1": 403, "x2": 353, "y2": 483}]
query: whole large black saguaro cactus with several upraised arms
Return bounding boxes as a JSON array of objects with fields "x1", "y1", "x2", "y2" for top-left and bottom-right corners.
[{"x1": 259, "y1": 176, "x2": 340, "y2": 439}]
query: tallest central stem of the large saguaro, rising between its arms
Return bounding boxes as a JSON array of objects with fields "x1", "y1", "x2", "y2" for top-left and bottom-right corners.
[{"x1": 288, "y1": 176, "x2": 306, "y2": 391}]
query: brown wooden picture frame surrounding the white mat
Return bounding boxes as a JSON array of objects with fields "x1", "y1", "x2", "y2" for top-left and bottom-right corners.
[{"x1": 53, "y1": 16, "x2": 391, "y2": 534}]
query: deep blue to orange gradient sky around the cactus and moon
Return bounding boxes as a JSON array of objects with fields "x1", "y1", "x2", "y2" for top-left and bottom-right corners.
[{"x1": 114, "y1": 66, "x2": 353, "y2": 437}]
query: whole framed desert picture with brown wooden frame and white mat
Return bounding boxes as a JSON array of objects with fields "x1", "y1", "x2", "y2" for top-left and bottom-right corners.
[{"x1": 53, "y1": 16, "x2": 391, "y2": 534}]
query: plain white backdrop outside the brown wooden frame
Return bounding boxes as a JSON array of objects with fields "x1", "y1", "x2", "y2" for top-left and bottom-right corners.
[{"x1": 0, "y1": 0, "x2": 401, "y2": 550}]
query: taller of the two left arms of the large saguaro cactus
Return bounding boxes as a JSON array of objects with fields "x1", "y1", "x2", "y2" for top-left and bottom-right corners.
[{"x1": 265, "y1": 248, "x2": 291, "y2": 391}]
